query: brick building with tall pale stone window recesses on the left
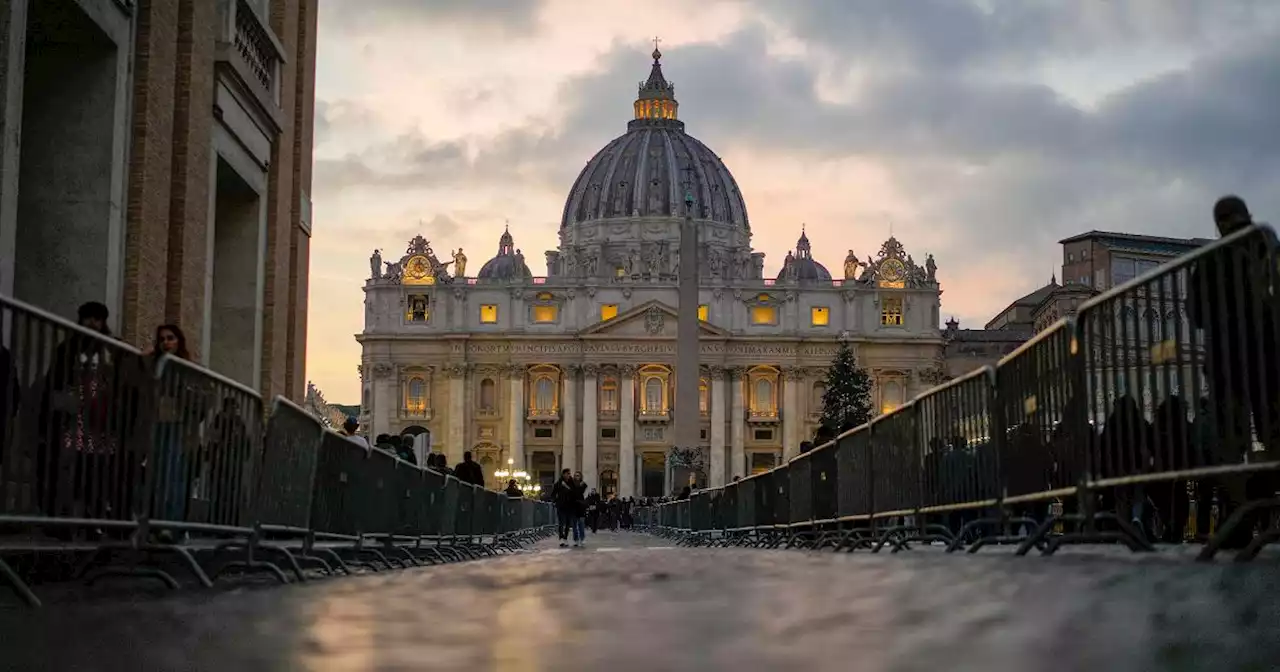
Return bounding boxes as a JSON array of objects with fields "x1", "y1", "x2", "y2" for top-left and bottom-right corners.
[{"x1": 0, "y1": 0, "x2": 316, "y2": 399}]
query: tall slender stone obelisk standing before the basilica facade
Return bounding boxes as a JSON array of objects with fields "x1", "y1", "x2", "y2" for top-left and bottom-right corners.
[{"x1": 672, "y1": 168, "x2": 701, "y2": 473}]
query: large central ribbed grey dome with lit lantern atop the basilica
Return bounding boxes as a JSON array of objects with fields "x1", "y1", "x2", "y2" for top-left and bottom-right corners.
[{"x1": 561, "y1": 49, "x2": 750, "y2": 233}]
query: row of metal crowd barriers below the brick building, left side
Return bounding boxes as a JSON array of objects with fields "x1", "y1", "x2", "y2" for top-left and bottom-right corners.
[{"x1": 0, "y1": 297, "x2": 553, "y2": 605}]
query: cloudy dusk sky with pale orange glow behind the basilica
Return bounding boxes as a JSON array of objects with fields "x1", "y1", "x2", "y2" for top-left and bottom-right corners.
[{"x1": 307, "y1": 0, "x2": 1280, "y2": 402}]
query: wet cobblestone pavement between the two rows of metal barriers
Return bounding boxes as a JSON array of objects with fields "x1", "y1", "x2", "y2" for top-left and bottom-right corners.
[{"x1": 0, "y1": 532, "x2": 1280, "y2": 672}]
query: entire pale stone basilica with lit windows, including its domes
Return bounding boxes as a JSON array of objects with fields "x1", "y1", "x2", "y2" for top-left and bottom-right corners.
[{"x1": 357, "y1": 50, "x2": 945, "y2": 497}]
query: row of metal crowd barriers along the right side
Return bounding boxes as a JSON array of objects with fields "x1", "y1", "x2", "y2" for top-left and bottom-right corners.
[{"x1": 637, "y1": 225, "x2": 1280, "y2": 559}]
